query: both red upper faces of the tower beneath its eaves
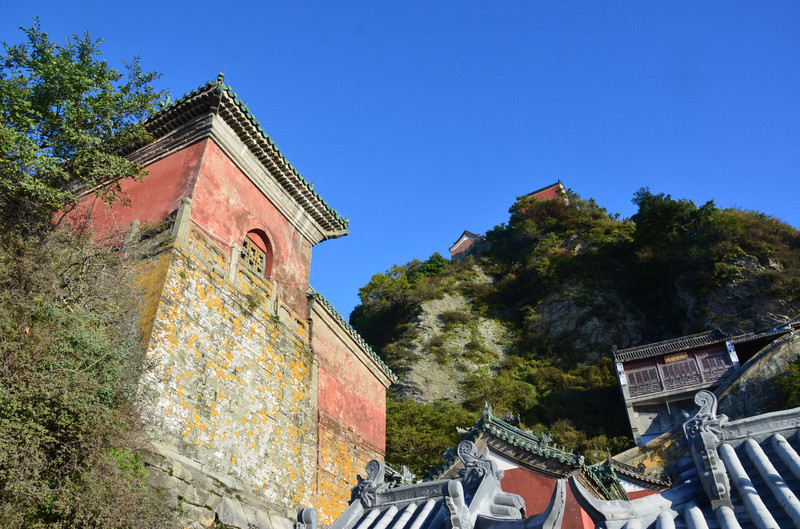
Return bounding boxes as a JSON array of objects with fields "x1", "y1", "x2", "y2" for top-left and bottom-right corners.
[{"x1": 76, "y1": 139, "x2": 311, "y2": 315}]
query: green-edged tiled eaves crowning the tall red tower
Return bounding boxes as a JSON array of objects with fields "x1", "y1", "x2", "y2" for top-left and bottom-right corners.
[{"x1": 137, "y1": 74, "x2": 349, "y2": 238}]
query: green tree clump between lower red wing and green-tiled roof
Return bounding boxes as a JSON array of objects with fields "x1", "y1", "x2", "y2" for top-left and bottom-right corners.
[{"x1": 386, "y1": 394, "x2": 478, "y2": 476}]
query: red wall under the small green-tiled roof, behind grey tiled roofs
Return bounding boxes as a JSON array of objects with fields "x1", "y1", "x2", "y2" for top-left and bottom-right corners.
[{"x1": 500, "y1": 468, "x2": 594, "y2": 529}]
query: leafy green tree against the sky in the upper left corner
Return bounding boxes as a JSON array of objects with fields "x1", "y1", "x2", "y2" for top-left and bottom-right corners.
[{"x1": 0, "y1": 20, "x2": 162, "y2": 232}]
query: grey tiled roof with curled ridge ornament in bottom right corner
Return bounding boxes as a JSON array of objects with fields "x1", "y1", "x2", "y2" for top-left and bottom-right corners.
[{"x1": 570, "y1": 391, "x2": 800, "y2": 529}]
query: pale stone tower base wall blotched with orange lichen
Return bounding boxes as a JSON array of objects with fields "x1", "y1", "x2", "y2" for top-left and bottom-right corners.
[{"x1": 140, "y1": 229, "x2": 317, "y2": 526}]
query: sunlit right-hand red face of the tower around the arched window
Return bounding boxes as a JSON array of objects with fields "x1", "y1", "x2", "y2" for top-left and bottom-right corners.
[{"x1": 192, "y1": 140, "x2": 311, "y2": 315}]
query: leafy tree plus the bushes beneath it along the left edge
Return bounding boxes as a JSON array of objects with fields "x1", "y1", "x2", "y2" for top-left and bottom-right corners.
[{"x1": 0, "y1": 21, "x2": 174, "y2": 528}]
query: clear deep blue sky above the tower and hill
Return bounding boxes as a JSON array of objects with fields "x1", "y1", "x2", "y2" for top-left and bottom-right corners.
[{"x1": 0, "y1": 0, "x2": 800, "y2": 316}]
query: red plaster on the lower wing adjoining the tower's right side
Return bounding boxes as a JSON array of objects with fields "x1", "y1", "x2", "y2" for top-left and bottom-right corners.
[{"x1": 311, "y1": 310, "x2": 386, "y2": 454}]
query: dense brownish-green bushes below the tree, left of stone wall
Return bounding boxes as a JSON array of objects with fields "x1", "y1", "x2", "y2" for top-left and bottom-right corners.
[{"x1": 0, "y1": 231, "x2": 170, "y2": 528}]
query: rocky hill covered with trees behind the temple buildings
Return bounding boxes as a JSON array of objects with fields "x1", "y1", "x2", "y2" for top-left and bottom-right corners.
[{"x1": 351, "y1": 190, "x2": 800, "y2": 466}]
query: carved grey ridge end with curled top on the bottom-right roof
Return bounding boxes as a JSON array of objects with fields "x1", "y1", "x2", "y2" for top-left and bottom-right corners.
[{"x1": 683, "y1": 390, "x2": 733, "y2": 510}]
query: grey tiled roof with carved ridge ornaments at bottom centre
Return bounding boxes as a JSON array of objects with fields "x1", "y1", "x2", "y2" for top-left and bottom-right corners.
[{"x1": 295, "y1": 441, "x2": 566, "y2": 529}]
